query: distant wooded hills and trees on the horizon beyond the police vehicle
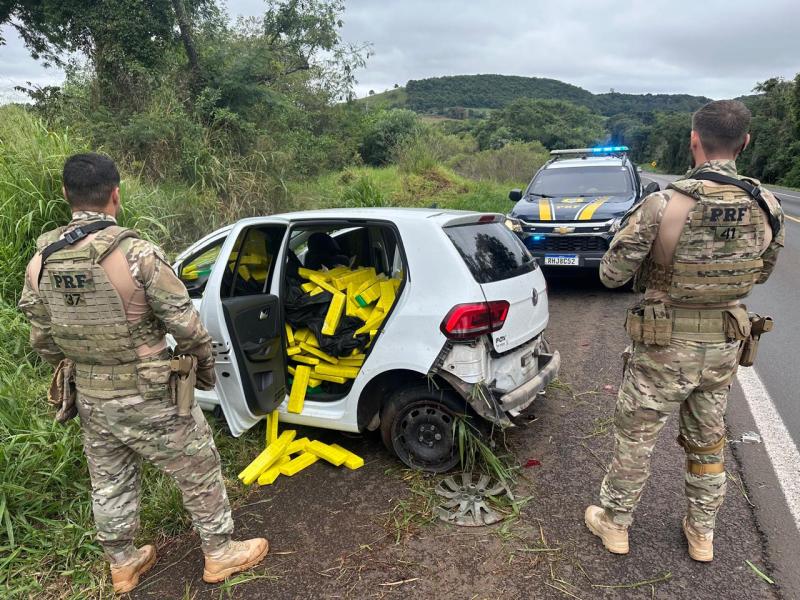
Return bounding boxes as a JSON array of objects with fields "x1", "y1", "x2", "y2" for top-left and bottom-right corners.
[{"x1": 372, "y1": 74, "x2": 800, "y2": 187}]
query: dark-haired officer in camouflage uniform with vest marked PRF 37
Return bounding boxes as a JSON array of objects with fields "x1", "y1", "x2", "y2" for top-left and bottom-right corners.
[{"x1": 19, "y1": 154, "x2": 268, "y2": 592}]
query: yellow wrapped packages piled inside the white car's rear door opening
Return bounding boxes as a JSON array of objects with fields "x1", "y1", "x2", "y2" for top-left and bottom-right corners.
[{"x1": 286, "y1": 267, "x2": 401, "y2": 413}]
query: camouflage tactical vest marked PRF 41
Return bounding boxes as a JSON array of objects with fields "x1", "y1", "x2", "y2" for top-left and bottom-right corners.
[{"x1": 637, "y1": 179, "x2": 767, "y2": 304}]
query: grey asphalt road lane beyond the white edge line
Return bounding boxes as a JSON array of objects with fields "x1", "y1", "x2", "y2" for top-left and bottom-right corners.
[{"x1": 643, "y1": 173, "x2": 800, "y2": 446}]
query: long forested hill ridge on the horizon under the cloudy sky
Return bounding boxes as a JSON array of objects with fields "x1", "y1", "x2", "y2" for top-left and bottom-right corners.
[{"x1": 362, "y1": 75, "x2": 709, "y2": 116}]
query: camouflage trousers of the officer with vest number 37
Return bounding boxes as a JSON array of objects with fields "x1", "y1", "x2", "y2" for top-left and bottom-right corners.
[{"x1": 78, "y1": 393, "x2": 233, "y2": 561}]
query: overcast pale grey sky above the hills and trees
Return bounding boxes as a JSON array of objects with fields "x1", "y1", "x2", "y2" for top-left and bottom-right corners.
[{"x1": 0, "y1": 0, "x2": 800, "y2": 99}]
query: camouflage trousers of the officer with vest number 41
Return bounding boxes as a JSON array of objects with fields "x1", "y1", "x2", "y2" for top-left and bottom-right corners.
[{"x1": 600, "y1": 339, "x2": 739, "y2": 533}]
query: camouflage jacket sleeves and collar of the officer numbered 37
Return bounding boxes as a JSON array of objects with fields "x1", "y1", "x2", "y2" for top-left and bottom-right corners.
[{"x1": 19, "y1": 211, "x2": 214, "y2": 367}]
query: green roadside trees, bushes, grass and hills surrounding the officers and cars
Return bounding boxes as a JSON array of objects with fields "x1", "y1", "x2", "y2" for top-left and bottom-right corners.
[{"x1": 0, "y1": 0, "x2": 800, "y2": 598}]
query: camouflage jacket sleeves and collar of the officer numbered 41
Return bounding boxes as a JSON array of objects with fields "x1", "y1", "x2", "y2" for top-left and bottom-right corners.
[{"x1": 600, "y1": 160, "x2": 785, "y2": 288}]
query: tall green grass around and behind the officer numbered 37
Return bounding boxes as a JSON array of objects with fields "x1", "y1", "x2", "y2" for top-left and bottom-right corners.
[{"x1": 0, "y1": 106, "x2": 262, "y2": 598}]
